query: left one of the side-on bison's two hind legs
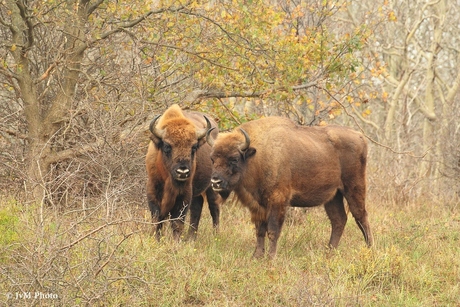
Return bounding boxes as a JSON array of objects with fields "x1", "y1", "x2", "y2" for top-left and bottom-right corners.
[{"x1": 324, "y1": 191, "x2": 347, "y2": 248}]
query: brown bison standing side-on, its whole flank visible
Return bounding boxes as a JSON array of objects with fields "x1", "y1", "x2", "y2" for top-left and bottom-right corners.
[{"x1": 207, "y1": 117, "x2": 372, "y2": 258}]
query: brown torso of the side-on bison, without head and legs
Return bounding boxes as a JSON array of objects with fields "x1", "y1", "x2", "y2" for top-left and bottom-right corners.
[{"x1": 241, "y1": 117, "x2": 367, "y2": 207}]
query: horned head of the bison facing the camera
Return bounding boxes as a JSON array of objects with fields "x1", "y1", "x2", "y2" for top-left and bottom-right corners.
[{"x1": 150, "y1": 115, "x2": 211, "y2": 183}]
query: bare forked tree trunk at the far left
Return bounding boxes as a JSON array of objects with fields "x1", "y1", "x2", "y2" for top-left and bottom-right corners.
[{"x1": 8, "y1": 0, "x2": 88, "y2": 202}]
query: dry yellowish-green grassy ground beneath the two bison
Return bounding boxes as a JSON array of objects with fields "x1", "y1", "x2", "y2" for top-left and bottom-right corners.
[{"x1": 0, "y1": 195, "x2": 460, "y2": 307}]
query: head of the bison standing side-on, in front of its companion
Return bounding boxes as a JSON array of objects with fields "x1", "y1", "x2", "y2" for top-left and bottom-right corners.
[{"x1": 206, "y1": 128, "x2": 256, "y2": 192}]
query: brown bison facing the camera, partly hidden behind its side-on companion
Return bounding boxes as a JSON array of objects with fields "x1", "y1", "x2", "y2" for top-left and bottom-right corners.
[{"x1": 145, "y1": 105, "x2": 220, "y2": 239}]
